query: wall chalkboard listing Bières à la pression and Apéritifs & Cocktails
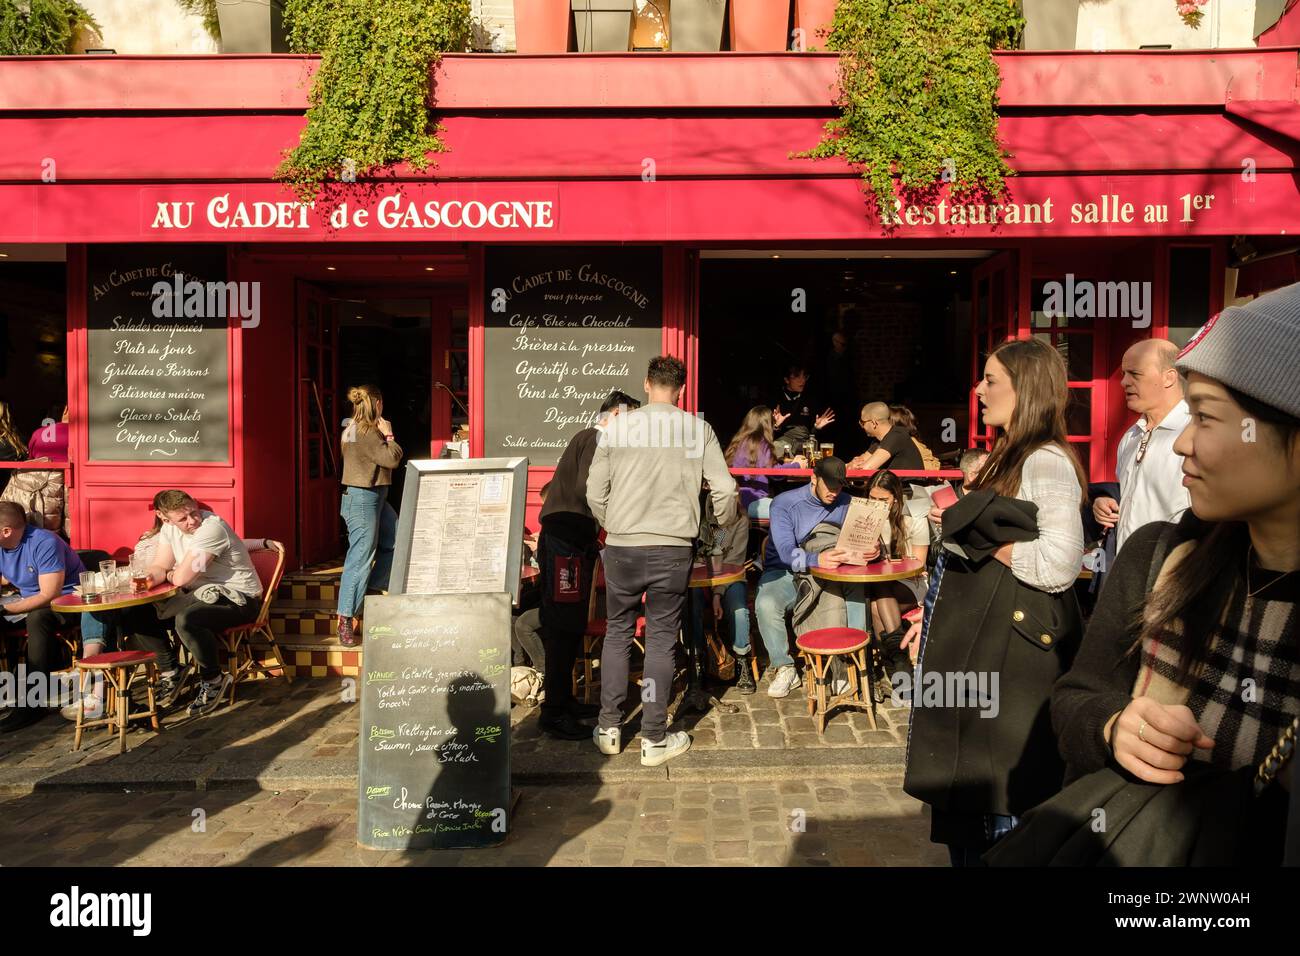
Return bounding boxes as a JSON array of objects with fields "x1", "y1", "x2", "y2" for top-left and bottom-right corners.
[{"x1": 484, "y1": 246, "x2": 663, "y2": 466}]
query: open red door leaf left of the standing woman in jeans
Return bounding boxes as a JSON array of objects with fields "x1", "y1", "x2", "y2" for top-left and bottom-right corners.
[{"x1": 295, "y1": 282, "x2": 345, "y2": 566}]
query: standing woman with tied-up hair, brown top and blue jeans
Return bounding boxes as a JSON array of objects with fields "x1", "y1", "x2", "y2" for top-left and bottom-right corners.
[{"x1": 338, "y1": 385, "x2": 402, "y2": 648}]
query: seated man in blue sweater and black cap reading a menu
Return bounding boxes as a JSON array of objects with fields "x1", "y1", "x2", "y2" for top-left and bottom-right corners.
[{"x1": 754, "y1": 458, "x2": 866, "y2": 697}]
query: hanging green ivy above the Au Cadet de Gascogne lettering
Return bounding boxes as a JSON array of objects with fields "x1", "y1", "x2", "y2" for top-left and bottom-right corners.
[{"x1": 276, "y1": 0, "x2": 471, "y2": 202}]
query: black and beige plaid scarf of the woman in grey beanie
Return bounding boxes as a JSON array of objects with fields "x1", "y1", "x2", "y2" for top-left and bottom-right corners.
[{"x1": 1132, "y1": 541, "x2": 1300, "y2": 769}]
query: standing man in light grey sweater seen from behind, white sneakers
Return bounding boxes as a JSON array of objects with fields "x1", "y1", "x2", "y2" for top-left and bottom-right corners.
[{"x1": 586, "y1": 355, "x2": 736, "y2": 766}]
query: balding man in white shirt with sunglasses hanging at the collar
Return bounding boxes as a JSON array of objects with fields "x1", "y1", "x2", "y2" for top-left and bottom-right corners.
[{"x1": 1092, "y1": 338, "x2": 1191, "y2": 553}]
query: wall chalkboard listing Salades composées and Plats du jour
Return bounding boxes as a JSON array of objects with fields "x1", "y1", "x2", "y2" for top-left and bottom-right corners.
[{"x1": 86, "y1": 245, "x2": 231, "y2": 462}]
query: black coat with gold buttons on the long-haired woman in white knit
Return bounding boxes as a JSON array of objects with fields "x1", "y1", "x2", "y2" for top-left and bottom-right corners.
[{"x1": 904, "y1": 492, "x2": 1083, "y2": 814}]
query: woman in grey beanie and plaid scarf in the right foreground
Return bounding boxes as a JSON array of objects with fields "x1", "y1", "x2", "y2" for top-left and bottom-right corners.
[{"x1": 989, "y1": 285, "x2": 1300, "y2": 865}]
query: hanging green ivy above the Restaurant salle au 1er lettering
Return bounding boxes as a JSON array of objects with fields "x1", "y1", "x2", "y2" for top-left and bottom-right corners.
[{"x1": 798, "y1": 0, "x2": 1024, "y2": 221}]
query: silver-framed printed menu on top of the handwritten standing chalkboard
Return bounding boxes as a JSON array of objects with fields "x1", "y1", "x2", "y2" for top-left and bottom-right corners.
[{"x1": 389, "y1": 458, "x2": 528, "y2": 601}]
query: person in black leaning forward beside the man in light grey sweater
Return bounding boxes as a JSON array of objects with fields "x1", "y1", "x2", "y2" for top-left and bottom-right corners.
[{"x1": 537, "y1": 392, "x2": 641, "y2": 740}]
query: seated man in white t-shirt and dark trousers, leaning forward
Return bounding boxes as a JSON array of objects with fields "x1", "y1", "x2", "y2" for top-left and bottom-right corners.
[{"x1": 129, "y1": 490, "x2": 261, "y2": 715}]
